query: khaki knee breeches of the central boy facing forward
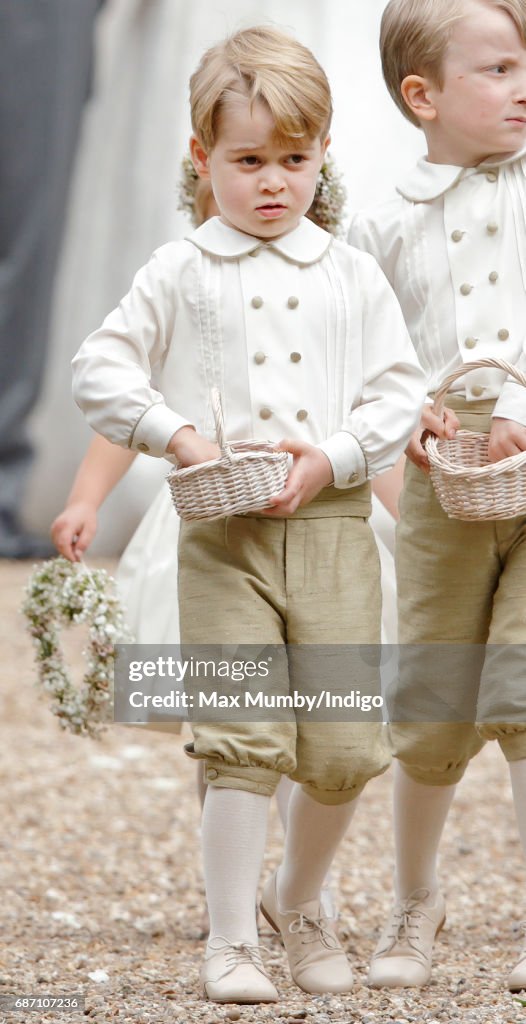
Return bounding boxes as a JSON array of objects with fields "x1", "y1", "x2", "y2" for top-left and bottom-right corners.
[{"x1": 179, "y1": 488, "x2": 390, "y2": 804}]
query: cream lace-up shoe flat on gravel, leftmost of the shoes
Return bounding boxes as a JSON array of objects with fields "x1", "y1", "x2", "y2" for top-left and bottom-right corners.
[{"x1": 200, "y1": 936, "x2": 277, "y2": 1002}]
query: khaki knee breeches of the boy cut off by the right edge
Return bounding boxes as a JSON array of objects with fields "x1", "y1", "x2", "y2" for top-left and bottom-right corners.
[{"x1": 389, "y1": 398, "x2": 526, "y2": 784}]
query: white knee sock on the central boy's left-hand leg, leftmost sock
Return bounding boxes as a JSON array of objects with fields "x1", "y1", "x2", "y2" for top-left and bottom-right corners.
[{"x1": 202, "y1": 785, "x2": 270, "y2": 945}]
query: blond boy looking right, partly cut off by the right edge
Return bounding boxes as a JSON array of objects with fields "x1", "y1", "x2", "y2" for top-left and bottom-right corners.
[{"x1": 350, "y1": 0, "x2": 526, "y2": 990}]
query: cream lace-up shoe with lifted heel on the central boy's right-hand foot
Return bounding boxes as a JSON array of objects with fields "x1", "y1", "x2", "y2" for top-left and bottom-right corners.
[{"x1": 260, "y1": 874, "x2": 352, "y2": 994}]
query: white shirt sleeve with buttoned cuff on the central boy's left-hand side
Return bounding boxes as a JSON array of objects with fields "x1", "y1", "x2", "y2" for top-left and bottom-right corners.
[{"x1": 73, "y1": 244, "x2": 188, "y2": 457}]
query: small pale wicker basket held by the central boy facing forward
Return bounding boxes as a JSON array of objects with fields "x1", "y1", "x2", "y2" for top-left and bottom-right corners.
[{"x1": 167, "y1": 388, "x2": 289, "y2": 519}]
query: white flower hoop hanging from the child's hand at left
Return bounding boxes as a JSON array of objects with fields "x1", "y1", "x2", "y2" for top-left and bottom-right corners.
[{"x1": 21, "y1": 558, "x2": 131, "y2": 737}]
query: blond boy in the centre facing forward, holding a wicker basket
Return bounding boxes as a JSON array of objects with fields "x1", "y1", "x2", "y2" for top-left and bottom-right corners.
[{"x1": 74, "y1": 28, "x2": 424, "y2": 1002}]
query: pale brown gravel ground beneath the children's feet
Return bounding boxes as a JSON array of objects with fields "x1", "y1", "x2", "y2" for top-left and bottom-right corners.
[{"x1": 0, "y1": 561, "x2": 526, "y2": 1024}]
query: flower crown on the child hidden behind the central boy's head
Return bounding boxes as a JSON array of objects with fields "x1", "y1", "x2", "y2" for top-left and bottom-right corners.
[{"x1": 177, "y1": 156, "x2": 347, "y2": 238}]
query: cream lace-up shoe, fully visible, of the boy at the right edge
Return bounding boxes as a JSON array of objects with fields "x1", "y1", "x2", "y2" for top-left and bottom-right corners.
[{"x1": 367, "y1": 889, "x2": 445, "y2": 988}]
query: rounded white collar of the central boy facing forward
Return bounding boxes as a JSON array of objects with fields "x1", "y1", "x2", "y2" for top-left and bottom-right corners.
[{"x1": 187, "y1": 217, "x2": 333, "y2": 265}]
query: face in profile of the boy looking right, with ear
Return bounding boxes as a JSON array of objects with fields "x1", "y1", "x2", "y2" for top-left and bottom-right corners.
[{"x1": 409, "y1": 0, "x2": 526, "y2": 167}]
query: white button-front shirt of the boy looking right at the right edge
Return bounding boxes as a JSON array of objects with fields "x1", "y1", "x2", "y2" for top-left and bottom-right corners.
[{"x1": 349, "y1": 152, "x2": 526, "y2": 425}]
